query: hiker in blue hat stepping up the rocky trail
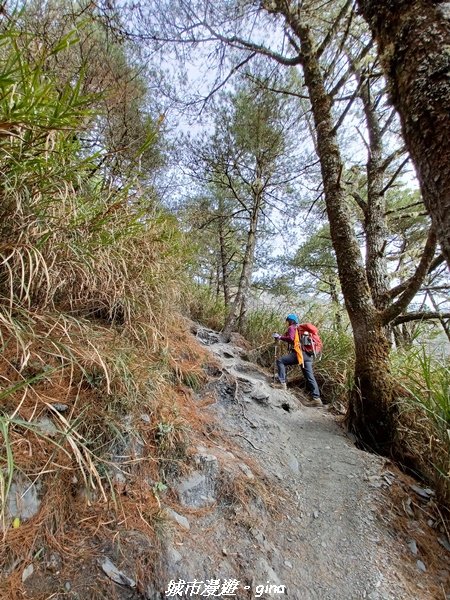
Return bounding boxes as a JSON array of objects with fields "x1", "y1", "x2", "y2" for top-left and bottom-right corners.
[{"x1": 273, "y1": 314, "x2": 323, "y2": 407}]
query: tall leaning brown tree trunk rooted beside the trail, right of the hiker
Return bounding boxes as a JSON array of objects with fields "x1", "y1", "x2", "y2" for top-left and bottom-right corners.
[{"x1": 286, "y1": 11, "x2": 393, "y2": 452}]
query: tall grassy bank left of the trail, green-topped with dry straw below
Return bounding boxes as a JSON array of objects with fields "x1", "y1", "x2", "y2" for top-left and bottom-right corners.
[{"x1": 0, "y1": 11, "x2": 225, "y2": 600}]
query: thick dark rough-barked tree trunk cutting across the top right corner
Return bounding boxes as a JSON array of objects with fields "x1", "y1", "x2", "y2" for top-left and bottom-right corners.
[{"x1": 358, "y1": 0, "x2": 450, "y2": 266}]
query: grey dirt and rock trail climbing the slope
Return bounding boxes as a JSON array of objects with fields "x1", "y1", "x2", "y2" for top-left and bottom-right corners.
[{"x1": 160, "y1": 328, "x2": 448, "y2": 600}]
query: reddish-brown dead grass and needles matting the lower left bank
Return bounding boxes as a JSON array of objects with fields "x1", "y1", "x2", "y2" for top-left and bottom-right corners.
[{"x1": 0, "y1": 321, "x2": 220, "y2": 599}]
